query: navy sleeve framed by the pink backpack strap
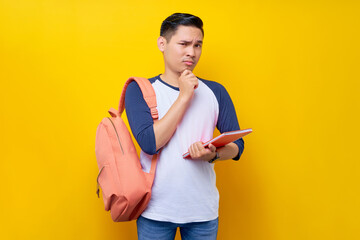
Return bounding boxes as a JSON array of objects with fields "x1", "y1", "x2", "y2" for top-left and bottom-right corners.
[{"x1": 125, "y1": 82, "x2": 156, "y2": 155}]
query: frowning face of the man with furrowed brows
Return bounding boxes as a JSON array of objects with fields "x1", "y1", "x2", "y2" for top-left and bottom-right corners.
[{"x1": 163, "y1": 26, "x2": 203, "y2": 74}]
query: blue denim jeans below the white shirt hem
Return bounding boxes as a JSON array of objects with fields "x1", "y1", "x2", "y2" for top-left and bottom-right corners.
[{"x1": 136, "y1": 216, "x2": 219, "y2": 240}]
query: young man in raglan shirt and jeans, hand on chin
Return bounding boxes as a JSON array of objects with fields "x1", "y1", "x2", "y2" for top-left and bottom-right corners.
[{"x1": 125, "y1": 13, "x2": 244, "y2": 240}]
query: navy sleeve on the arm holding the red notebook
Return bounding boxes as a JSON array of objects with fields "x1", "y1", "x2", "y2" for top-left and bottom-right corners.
[{"x1": 202, "y1": 80, "x2": 244, "y2": 160}]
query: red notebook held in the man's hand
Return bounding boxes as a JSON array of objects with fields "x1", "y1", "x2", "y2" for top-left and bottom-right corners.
[{"x1": 183, "y1": 128, "x2": 252, "y2": 158}]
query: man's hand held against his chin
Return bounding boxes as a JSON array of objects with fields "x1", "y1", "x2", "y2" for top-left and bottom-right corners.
[{"x1": 179, "y1": 69, "x2": 199, "y2": 100}]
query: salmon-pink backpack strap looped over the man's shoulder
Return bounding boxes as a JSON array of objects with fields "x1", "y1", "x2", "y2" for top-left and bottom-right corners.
[{"x1": 118, "y1": 77, "x2": 159, "y2": 119}]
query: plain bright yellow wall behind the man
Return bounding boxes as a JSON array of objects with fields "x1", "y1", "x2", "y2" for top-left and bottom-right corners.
[{"x1": 0, "y1": 0, "x2": 360, "y2": 240}]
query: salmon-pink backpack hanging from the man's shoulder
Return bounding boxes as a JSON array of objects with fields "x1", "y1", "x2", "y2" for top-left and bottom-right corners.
[{"x1": 95, "y1": 77, "x2": 158, "y2": 222}]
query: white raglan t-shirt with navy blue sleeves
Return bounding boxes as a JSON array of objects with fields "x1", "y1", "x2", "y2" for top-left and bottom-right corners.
[{"x1": 125, "y1": 75, "x2": 244, "y2": 223}]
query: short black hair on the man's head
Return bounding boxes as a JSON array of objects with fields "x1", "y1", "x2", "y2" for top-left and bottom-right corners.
[{"x1": 160, "y1": 13, "x2": 204, "y2": 42}]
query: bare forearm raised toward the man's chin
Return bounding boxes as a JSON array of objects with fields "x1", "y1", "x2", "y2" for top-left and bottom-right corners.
[{"x1": 153, "y1": 95, "x2": 190, "y2": 151}]
